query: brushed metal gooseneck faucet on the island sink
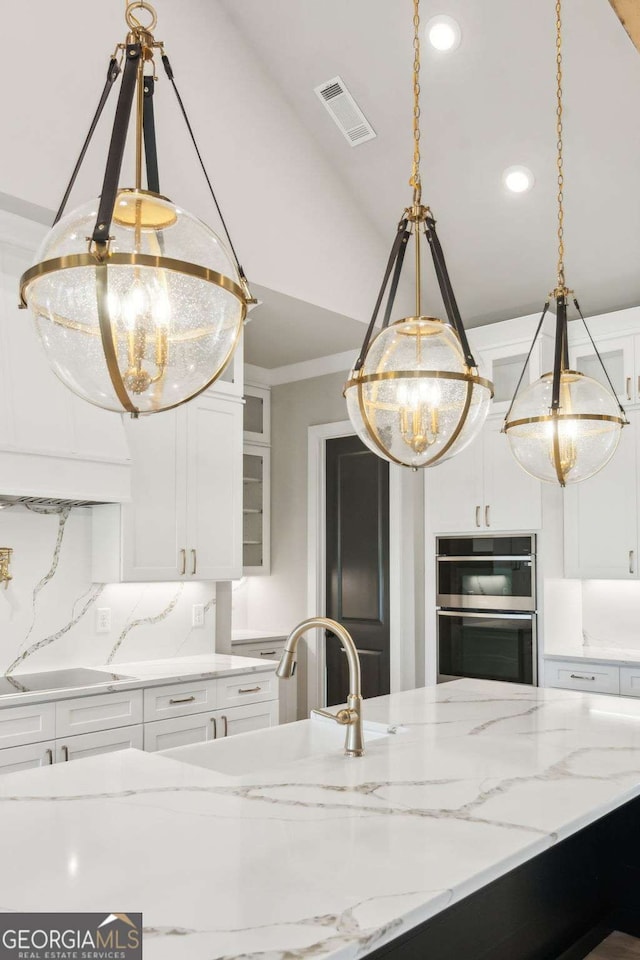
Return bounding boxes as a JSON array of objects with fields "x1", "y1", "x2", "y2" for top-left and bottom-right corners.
[{"x1": 276, "y1": 617, "x2": 364, "y2": 757}]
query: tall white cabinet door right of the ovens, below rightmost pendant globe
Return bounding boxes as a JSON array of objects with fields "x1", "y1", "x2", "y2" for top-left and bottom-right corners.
[{"x1": 564, "y1": 411, "x2": 640, "y2": 580}]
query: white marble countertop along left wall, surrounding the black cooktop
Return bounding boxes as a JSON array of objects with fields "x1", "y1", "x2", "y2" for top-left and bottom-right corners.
[{"x1": 0, "y1": 653, "x2": 275, "y2": 709}]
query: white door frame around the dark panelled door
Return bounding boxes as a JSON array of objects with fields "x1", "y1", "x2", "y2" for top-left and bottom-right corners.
[{"x1": 307, "y1": 420, "x2": 424, "y2": 710}]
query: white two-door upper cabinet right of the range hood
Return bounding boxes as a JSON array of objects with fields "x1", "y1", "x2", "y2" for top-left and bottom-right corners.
[{"x1": 93, "y1": 393, "x2": 242, "y2": 583}]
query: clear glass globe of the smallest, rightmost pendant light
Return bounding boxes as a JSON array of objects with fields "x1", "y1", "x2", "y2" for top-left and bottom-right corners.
[{"x1": 505, "y1": 370, "x2": 625, "y2": 486}]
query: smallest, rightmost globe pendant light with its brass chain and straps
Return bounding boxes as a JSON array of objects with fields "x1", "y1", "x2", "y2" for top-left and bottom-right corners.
[{"x1": 503, "y1": 0, "x2": 628, "y2": 487}]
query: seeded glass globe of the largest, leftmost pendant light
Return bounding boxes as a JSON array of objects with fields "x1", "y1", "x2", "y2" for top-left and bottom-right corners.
[{"x1": 25, "y1": 190, "x2": 245, "y2": 413}]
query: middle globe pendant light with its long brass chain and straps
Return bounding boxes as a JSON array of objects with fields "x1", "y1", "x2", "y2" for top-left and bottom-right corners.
[{"x1": 344, "y1": 0, "x2": 493, "y2": 469}]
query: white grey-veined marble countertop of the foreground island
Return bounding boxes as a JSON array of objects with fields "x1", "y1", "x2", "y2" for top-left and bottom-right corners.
[{"x1": 0, "y1": 680, "x2": 640, "y2": 960}]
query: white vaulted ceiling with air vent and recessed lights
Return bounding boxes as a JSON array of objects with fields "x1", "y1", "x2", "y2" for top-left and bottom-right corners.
[{"x1": 0, "y1": 0, "x2": 640, "y2": 366}]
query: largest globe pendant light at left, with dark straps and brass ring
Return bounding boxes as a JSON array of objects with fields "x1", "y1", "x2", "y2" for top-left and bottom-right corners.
[{"x1": 20, "y1": 0, "x2": 255, "y2": 417}]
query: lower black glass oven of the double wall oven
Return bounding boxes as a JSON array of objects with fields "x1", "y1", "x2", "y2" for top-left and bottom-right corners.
[{"x1": 438, "y1": 610, "x2": 537, "y2": 684}]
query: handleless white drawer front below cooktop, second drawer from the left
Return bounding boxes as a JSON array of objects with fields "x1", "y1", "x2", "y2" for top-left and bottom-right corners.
[{"x1": 55, "y1": 690, "x2": 142, "y2": 739}]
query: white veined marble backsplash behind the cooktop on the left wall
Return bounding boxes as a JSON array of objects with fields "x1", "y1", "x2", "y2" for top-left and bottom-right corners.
[{"x1": 0, "y1": 506, "x2": 216, "y2": 674}]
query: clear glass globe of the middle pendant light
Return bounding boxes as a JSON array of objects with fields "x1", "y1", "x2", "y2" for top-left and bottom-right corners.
[{"x1": 345, "y1": 317, "x2": 493, "y2": 467}]
